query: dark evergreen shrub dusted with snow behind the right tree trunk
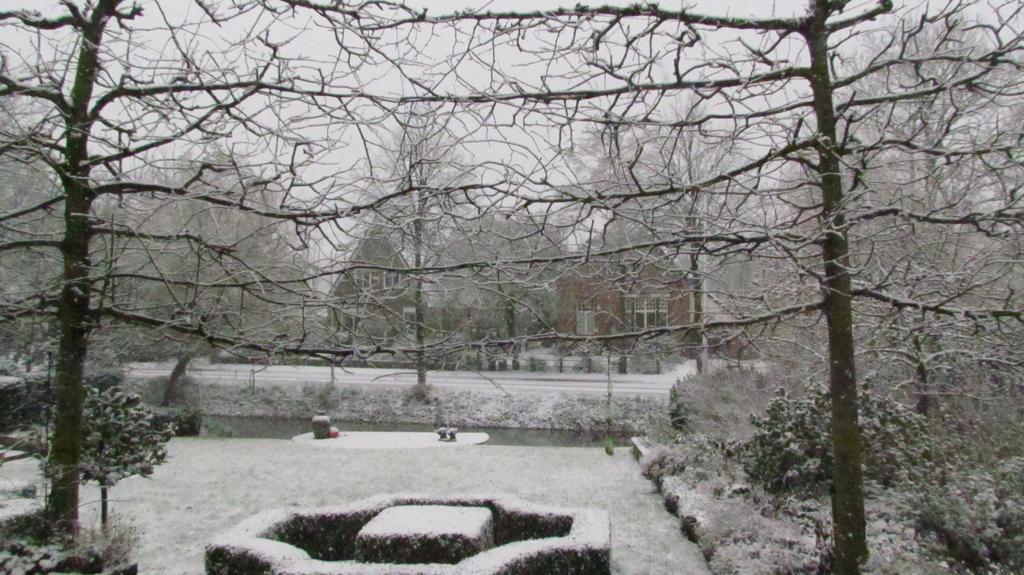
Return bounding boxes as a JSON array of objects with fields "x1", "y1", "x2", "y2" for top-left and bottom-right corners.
[{"x1": 743, "y1": 389, "x2": 931, "y2": 492}]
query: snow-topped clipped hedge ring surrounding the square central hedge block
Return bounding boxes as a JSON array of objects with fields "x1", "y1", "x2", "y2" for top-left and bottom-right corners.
[{"x1": 206, "y1": 495, "x2": 611, "y2": 575}]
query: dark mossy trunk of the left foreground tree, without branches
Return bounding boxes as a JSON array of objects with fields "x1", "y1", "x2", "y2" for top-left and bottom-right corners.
[{"x1": 46, "y1": 5, "x2": 111, "y2": 533}]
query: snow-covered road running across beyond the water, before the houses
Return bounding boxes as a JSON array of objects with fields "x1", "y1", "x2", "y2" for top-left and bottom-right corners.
[{"x1": 126, "y1": 363, "x2": 690, "y2": 397}]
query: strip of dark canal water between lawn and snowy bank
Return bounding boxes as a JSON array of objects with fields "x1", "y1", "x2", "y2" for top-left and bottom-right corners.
[{"x1": 203, "y1": 415, "x2": 631, "y2": 447}]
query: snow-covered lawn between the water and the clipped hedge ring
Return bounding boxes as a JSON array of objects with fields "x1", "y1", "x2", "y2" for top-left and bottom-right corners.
[{"x1": 59, "y1": 438, "x2": 708, "y2": 574}]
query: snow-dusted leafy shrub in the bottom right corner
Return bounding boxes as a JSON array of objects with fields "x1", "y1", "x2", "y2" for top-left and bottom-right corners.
[{"x1": 920, "y1": 457, "x2": 1024, "y2": 573}]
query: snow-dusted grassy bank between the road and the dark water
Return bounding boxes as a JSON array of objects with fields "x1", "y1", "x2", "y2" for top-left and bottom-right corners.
[{"x1": 128, "y1": 380, "x2": 667, "y2": 432}]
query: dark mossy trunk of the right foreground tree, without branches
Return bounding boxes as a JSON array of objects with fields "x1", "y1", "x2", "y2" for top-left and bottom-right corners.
[{"x1": 804, "y1": 0, "x2": 867, "y2": 575}]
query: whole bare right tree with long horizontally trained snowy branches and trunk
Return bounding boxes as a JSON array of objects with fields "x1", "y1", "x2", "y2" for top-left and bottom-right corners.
[{"x1": 280, "y1": 0, "x2": 1022, "y2": 573}]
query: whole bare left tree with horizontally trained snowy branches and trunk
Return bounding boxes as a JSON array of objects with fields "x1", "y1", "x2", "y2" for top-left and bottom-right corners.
[{"x1": 0, "y1": 0, "x2": 315, "y2": 530}]
